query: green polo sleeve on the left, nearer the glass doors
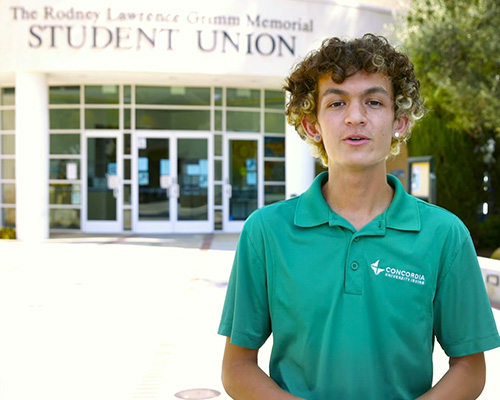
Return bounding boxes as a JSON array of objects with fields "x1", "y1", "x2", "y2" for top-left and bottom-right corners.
[{"x1": 218, "y1": 215, "x2": 271, "y2": 349}]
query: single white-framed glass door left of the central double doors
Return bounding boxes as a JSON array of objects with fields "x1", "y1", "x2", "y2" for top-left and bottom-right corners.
[{"x1": 82, "y1": 132, "x2": 123, "y2": 233}]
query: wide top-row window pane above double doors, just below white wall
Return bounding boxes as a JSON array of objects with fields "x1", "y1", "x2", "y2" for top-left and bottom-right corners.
[{"x1": 135, "y1": 86, "x2": 210, "y2": 106}]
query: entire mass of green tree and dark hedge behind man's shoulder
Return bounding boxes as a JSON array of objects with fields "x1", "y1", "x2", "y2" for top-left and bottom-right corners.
[{"x1": 393, "y1": 0, "x2": 500, "y2": 250}]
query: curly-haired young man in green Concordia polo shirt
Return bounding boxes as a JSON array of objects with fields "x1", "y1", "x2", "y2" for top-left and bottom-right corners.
[{"x1": 219, "y1": 35, "x2": 500, "y2": 400}]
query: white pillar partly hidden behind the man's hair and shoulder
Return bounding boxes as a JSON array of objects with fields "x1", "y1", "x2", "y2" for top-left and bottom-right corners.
[{"x1": 285, "y1": 124, "x2": 315, "y2": 199}]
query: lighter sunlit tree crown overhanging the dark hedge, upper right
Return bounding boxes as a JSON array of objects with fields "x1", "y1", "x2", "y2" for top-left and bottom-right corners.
[{"x1": 396, "y1": 0, "x2": 500, "y2": 137}]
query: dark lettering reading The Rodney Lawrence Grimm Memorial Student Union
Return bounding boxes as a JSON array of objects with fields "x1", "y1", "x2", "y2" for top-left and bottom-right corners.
[{"x1": 14, "y1": 6, "x2": 314, "y2": 57}]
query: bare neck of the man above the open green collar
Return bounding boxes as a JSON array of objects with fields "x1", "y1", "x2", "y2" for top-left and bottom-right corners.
[{"x1": 322, "y1": 168, "x2": 394, "y2": 230}]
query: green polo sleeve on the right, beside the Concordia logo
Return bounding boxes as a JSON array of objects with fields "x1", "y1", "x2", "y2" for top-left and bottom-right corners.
[{"x1": 434, "y1": 228, "x2": 500, "y2": 357}]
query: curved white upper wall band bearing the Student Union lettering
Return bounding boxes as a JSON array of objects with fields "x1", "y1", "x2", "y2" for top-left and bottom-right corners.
[{"x1": 0, "y1": 0, "x2": 391, "y2": 76}]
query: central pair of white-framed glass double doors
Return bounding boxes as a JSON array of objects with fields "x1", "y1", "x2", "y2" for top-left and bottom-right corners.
[{"x1": 132, "y1": 132, "x2": 213, "y2": 233}]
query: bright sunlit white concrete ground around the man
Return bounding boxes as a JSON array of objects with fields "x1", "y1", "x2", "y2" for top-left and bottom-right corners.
[{"x1": 0, "y1": 234, "x2": 500, "y2": 400}]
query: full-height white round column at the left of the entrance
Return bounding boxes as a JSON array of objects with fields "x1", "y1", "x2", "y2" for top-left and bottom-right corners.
[{"x1": 15, "y1": 72, "x2": 49, "y2": 242}]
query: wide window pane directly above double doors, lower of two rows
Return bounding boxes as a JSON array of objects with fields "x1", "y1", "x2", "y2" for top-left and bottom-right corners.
[{"x1": 135, "y1": 110, "x2": 210, "y2": 131}]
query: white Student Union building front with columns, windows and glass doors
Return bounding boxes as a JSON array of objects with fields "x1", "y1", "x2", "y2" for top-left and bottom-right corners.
[{"x1": 0, "y1": 0, "x2": 398, "y2": 240}]
